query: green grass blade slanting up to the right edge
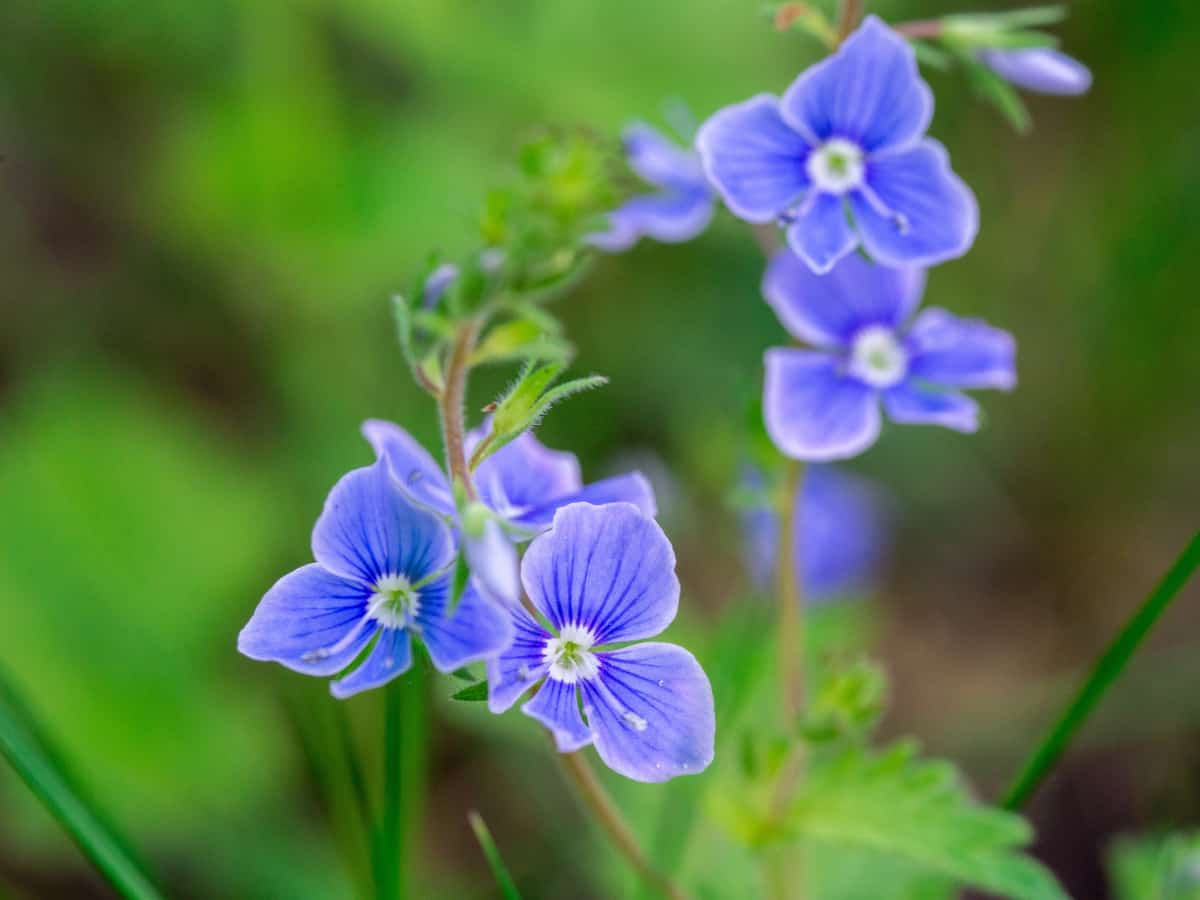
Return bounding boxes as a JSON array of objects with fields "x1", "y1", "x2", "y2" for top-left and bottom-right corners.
[{"x1": 1004, "y1": 532, "x2": 1200, "y2": 810}]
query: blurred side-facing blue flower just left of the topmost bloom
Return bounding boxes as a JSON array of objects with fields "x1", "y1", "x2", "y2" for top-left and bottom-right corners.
[{"x1": 586, "y1": 124, "x2": 714, "y2": 253}]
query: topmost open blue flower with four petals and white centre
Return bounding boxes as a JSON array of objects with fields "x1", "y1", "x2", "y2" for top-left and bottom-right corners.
[{"x1": 696, "y1": 16, "x2": 979, "y2": 272}]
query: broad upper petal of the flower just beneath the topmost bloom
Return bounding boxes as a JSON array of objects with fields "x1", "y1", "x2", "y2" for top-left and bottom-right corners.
[{"x1": 762, "y1": 250, "x2": 925, "y2": 348}]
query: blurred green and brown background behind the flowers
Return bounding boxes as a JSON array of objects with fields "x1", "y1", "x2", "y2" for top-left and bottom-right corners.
[{"x1": 0, "y1": 0, "x2": 1200, "y2": 899}]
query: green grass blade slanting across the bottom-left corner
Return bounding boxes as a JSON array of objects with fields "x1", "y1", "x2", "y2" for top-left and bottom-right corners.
[{"x1": 0, "y1": 683, "x2": 161, "y2": 900}]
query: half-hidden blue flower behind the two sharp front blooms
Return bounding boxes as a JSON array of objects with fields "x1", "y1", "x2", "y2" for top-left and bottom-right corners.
[{"x1": 362, "y1": 419, "x2": 656, "y2": 604}]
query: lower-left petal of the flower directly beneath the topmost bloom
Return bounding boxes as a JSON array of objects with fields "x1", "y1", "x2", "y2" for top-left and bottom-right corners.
[{"x1": 763, "y1": 348, "x2": 881, "y2": 462}]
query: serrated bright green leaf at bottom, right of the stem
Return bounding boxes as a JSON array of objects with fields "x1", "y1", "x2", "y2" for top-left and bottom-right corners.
[{"x1": 786, "y1": 744, "x2": 1067, "y2": 900}]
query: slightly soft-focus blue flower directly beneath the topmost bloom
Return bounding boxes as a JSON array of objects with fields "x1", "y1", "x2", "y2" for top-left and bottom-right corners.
[{"x1": 763, "y1": 250, "x2": 1016, "y2": 461}]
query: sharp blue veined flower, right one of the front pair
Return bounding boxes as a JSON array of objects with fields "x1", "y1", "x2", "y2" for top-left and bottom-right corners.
[{"x1": 487, "y1": 503, "x2": 715, "y2": 781}]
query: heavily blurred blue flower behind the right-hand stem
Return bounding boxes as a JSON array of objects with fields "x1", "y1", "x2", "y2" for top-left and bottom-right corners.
[{"x1": 742, "y1": 466, "x2": 888, "y2": 604}]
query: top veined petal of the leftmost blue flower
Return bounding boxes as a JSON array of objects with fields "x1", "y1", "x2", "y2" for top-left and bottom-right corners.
[{"x1": 312, "y1": 458, "x2": 454, "y2": 584}]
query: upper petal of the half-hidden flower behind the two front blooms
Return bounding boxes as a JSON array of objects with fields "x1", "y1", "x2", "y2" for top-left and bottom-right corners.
[{"x1": 468, "y1": 428, "x2": 583, "y2": 518}]
